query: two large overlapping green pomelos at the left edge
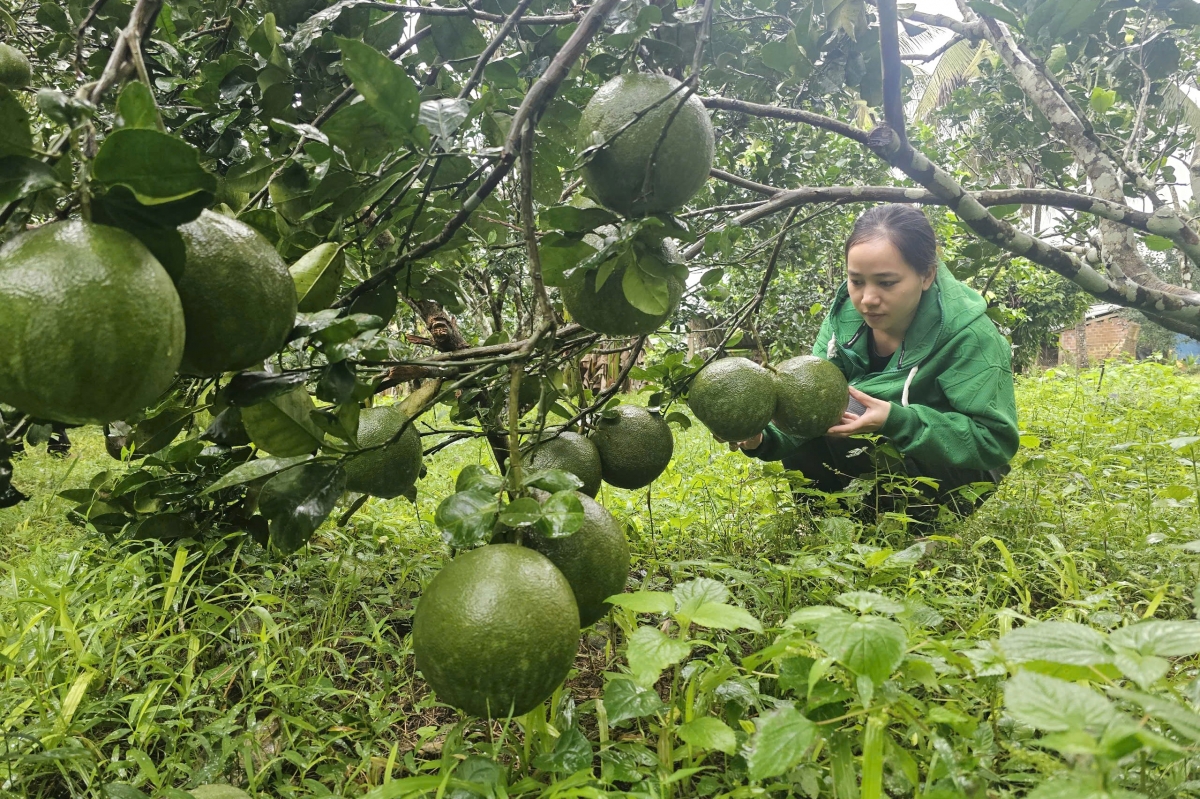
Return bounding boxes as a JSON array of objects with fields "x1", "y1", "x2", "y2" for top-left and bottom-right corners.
[{"x1": 0, "y1": 211, "x2": 296, "y2": 423}]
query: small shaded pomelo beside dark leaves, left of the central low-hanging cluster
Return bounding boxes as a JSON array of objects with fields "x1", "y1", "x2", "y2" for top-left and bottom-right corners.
[{"x1": 346, "y1": 405, "x2": 421, "y2": 499}]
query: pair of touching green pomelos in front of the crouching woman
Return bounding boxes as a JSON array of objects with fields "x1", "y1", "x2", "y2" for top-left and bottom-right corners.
[{"x1": 688, "y1": 355, "x2": 850, "y2": 441}]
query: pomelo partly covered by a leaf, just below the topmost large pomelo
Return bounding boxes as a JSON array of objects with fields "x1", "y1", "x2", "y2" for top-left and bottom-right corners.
[{"x1": 558, "y1": 239, "x2": 684, "y2": 336}]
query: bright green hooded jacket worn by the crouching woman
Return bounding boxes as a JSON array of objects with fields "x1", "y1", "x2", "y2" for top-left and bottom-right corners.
[{"x1": 746, "y1": 264, "x2": 1019, "y2": 470}]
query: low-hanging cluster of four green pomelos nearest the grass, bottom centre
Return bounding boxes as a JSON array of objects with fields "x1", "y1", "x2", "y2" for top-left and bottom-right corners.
[{"x1": 413, "y1": 405, "x2": 674, "y2": 716}]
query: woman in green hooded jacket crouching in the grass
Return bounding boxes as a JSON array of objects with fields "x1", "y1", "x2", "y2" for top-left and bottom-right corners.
[{"x1": 731, "y1": 205, "x2": 1018, "y2": 518}]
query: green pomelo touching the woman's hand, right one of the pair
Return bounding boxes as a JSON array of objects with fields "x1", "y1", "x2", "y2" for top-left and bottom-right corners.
[{"x1": 773, "y1": 355, "x2": 850, "y2": 438}]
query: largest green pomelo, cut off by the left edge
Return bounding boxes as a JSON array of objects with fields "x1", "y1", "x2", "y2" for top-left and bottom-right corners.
[{"x1": 0, "y1": 221, "x2": 184, "y2": 425}]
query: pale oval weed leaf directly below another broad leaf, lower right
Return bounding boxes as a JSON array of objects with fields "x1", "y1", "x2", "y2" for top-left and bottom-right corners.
[{"x1": 1004, "y1": 671, "x2": 1120, "y2": 732}]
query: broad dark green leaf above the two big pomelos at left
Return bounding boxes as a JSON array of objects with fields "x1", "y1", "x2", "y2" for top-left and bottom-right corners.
[{"x1": 92, "y1": 127, "x2": 217, "y2": 205}]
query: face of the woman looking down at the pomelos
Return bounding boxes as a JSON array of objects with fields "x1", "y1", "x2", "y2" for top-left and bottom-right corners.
[{"x1": 846, "y1": 238, "x2": 936, "y2": 340}]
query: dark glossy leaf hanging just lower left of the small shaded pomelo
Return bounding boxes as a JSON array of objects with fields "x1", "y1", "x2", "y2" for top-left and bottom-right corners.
[{"x1": 258, "y1": 463, "x2": 346, "y2": 554}]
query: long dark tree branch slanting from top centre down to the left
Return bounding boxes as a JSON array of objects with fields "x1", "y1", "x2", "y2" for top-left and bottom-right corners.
[{"x1": 334, "y1": 0, "x2": 617, "y2": 307}]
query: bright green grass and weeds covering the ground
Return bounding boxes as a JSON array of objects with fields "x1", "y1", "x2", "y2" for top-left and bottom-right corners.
[{"x1": 0, "y1": 364, "x2": 1200, "y2": 799}]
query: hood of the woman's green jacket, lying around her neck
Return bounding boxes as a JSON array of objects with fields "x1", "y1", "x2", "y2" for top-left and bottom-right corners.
[{"x1": 829, "y1": 262, "x2": 988, "y2": 368}]
